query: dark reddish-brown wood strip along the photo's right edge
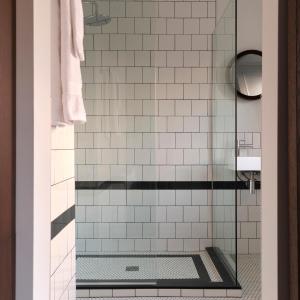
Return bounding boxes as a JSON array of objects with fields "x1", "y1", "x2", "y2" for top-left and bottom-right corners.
[{"x1": 287, "y1": 0, "x2": 300, "y2": 300}]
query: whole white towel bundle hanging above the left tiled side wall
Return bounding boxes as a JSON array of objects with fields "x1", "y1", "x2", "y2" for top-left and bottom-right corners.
[{"x1": 52, "y1": 0, "x2": 86, "y2": 126}]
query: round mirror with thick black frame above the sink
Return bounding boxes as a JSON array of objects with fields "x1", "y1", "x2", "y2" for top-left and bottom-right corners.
[{"x1": 236, "y1": 50, "x2": 262, "y2": 100}]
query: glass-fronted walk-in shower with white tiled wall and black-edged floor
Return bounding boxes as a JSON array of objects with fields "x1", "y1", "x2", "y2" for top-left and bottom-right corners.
[{"x1": 75, "y1": 0, "x2": 239, "y2": 289}]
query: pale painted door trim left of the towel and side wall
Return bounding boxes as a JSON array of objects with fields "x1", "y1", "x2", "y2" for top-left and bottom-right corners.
[{"x1": 16, "y1": 0, "x2": 51, "y2": 300}]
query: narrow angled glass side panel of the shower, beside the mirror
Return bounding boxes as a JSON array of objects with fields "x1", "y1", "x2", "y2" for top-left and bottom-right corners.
[{"x1": 212, "y1": 0, "x2": 237, "y2": 280}]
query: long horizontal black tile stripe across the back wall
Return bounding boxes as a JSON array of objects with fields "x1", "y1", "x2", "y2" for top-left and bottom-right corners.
[{"x1": 75, "y1": 181, "x2": 260, "y2": 190}]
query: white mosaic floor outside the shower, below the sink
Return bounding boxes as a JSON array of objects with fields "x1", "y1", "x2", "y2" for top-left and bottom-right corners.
[{"x1": 77, "y1": 255, "x2": 261, "y2": 300}]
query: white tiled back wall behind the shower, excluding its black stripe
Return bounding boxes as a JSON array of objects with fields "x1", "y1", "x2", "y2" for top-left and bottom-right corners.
[{"x1": 75, "y1": 0, "x2": 260, "y2": 254}]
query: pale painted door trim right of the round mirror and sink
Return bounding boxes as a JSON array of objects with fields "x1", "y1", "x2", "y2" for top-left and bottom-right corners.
[{"x1": 261, "y1": 0, "x2": 278, "y2": 300}]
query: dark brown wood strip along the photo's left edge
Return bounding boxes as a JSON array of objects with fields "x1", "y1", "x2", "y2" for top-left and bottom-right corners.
[{"x1": 0, "y1": 0, "x2": 15, "y2": 300}]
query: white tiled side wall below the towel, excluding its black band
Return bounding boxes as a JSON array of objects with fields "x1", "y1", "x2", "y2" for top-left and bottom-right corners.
[{"x1": 50, "y1": 126, "x2": 75, "y2": 300}]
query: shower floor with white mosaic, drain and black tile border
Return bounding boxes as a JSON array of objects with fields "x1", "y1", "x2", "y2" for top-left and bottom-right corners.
[{"x1": 76, "y1": 248, "x2": 240, "y2": 289}]
